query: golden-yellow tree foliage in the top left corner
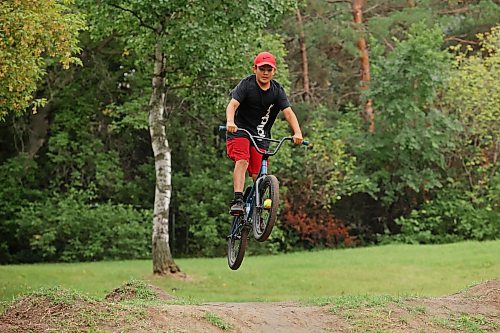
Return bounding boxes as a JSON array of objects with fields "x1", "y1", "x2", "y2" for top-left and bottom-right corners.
[{"x1": 0, "y1": 0, "x2": 85, "y2": 120}]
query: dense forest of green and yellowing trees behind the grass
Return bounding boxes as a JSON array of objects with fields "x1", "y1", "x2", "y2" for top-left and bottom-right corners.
[{"x1": 0, "y1": 0, "x2": 500, "y2": 264}]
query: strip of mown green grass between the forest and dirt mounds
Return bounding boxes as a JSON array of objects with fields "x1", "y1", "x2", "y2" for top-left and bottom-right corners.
[{"x1": 0, "y1": 241, "x2": 500, "y2": 303}]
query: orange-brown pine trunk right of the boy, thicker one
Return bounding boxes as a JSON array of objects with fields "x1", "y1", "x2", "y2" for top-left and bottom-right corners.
[{"x1": 352, "y1": 0, "x2": 375, "y2": 132}]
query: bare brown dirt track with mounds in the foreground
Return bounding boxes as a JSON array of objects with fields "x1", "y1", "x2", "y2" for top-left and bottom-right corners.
[{"x1": 0, "y1": 280, "x2": 500, "y2": 333}]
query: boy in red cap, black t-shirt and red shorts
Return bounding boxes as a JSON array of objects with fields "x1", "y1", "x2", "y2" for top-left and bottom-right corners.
[{"x1": 226, "y1": 52, "x2": 303, "y2": 216}]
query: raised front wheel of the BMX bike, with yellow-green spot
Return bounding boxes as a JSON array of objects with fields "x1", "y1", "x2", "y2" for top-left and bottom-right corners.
[{"x1": 252, "y1": 175, "x2": 279, "y2": 242}]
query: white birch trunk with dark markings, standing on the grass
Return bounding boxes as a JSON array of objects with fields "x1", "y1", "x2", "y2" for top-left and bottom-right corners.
[{"x1": 149, "y1": 36, "x2": 180, "y2": 275}]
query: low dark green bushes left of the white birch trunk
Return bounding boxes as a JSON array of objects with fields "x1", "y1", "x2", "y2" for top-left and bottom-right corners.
[{"x1": 7, "y1": 192, "x2": 152, "y2": 262}]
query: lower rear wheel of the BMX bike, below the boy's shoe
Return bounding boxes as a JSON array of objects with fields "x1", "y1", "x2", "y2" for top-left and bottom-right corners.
[{"x1": 227, "y1": 216, "x2": 249, "y2": 270}]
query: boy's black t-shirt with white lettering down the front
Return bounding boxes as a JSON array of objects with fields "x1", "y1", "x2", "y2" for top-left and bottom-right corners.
[{"x1": 227, "y1": 75, "x2": 290, "y2": 148}]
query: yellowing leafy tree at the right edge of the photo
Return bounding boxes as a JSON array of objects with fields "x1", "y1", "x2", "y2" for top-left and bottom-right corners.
[{"x1": 444, "y1": 25, "x2": 500, "y2": 200}]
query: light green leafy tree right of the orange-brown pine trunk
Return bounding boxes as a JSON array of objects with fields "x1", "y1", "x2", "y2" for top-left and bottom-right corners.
[{"x1": 363, "y1": 23, "x2": 457, "y2": 231}]
